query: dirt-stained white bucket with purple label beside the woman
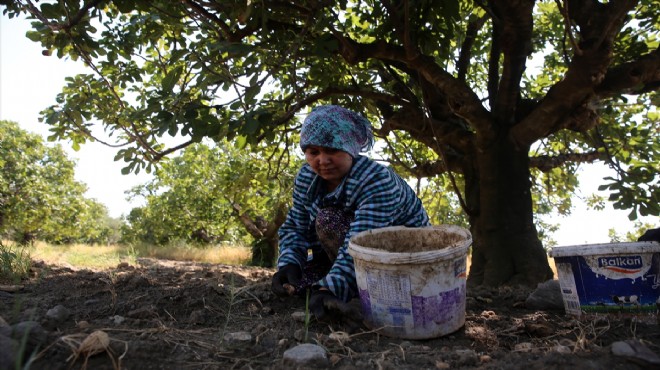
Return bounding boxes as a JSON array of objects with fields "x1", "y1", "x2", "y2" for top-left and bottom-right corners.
[{"x1": 348, "y1": 225, "x2": 472, "y2": 339}]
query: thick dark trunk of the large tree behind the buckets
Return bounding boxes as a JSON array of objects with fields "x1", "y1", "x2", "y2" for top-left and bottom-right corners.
[{"x1": 466, "y1": 135, "x2": 553, "y2": 286}]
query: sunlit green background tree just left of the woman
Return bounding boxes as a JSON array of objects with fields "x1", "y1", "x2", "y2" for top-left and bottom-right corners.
[{"x1": 127, "y1": 142, "x2": 300, "y2": 267}]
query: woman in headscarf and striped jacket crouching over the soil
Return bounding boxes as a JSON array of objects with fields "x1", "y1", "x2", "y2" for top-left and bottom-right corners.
[{"x1": 272, "y1": 105, "x2": 429, "y2": 319}]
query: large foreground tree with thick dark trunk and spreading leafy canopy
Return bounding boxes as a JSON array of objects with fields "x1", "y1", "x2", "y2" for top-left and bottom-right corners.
[{"x1": 5, "y1": 0, "x2": 660, "y2": 285}]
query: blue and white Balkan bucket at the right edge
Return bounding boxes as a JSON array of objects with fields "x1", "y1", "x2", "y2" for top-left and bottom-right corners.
[{"x1": 550, "y1": 242, "x2": 660, "y2": 316}]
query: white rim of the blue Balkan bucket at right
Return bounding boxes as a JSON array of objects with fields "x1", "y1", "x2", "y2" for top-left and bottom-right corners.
[{"x1": 549, "y1": 241, "x2": 660, "y2": 258}]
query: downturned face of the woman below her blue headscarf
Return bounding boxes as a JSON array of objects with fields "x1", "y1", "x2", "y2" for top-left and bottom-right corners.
[{"x1": 305, "y1": 145, "x2": 353, "y2": 191}]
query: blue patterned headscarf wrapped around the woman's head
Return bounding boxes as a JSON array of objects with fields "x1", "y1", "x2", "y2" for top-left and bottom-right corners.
[{"x1": 300, "y1": 105, "x2": 374, "y2": 158}]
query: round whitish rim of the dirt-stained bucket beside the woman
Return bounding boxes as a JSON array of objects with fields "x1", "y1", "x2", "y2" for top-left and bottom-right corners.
[{"x1": 348, "y1": 224, "x2": 472, "y2": 264}]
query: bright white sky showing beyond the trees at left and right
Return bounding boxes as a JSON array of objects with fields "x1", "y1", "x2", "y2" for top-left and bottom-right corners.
[{"x1": 0, "y1": 15, "x2": 660, "y2": 246}]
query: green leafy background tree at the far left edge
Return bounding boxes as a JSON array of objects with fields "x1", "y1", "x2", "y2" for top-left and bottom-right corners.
[{"x1": 0, "y1": 121, "x2": 115, "y2": 243}]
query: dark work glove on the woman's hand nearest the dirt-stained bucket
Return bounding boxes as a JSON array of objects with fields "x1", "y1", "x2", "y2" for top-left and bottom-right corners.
[{"x1": 309, "y1": 290, "x2": 362, "y2": 332}]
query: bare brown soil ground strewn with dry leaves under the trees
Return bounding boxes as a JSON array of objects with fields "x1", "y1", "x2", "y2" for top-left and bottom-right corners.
[{"x1": 0, "y1": 259, "x2": 660, "y2": 370}]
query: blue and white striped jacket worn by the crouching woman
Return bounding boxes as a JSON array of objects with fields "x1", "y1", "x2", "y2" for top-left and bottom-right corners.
[{"x1": 277, "y1": 156, "x2": 429, "y2": 301}]
